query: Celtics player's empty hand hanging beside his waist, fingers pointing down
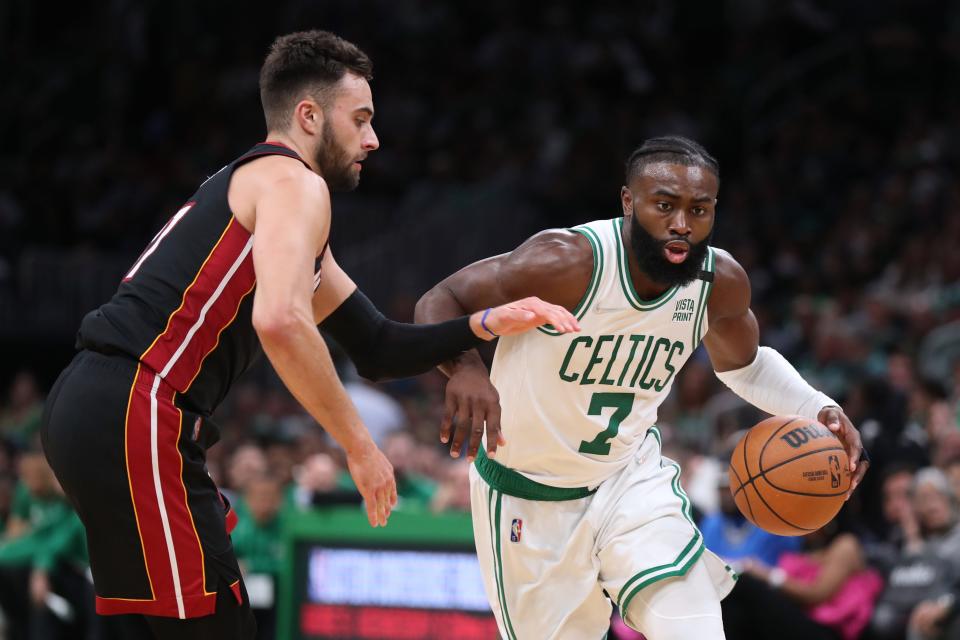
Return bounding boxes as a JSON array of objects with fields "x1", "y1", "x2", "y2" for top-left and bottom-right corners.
[{"x1": 440, "y1": 356, "x2": 507, "y2": 462}]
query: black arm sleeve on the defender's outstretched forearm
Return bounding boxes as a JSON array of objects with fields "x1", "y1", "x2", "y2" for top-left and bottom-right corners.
[{"x1": 320, "y1": 289, "x2": 484, "y2": 381}]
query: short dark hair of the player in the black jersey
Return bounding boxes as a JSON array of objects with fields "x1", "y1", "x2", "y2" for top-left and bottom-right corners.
[{"x1": 260, "y1": 30, "x2": 373, "y2": 130}]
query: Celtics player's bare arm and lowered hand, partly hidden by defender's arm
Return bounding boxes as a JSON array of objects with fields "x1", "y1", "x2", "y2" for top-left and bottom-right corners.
[{"x1": 414, "y1": 229, "x2": 593, "y2": 460}]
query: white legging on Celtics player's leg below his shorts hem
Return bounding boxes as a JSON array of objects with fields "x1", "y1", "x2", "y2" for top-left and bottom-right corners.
[{"x1": 621, "y1": 559, "x2": 724, "y2": 640}]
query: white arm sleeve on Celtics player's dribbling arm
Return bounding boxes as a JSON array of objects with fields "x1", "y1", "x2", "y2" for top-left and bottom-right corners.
[{"x1": 714, "y1": 347, "x2": 838, "y2": 420}]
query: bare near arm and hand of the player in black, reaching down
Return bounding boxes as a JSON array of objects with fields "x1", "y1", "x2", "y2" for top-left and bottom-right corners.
[{"x1": 253, "y1": 168, "x2": 397, "y2": 526}]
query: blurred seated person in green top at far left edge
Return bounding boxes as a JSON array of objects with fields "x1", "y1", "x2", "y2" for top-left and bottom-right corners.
[{"x1": 0, "y1": 452, "x2": 93, "y2": 640}]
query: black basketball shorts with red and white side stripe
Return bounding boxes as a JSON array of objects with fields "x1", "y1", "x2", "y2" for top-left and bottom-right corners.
[{"x1": 41, "y1": 351, "x2": 242, "y2": 618}]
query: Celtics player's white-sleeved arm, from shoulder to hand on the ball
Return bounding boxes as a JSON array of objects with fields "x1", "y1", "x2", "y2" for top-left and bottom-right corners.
[{"x1": 703, "y1": 250, "x2": 870, "y2": 498}]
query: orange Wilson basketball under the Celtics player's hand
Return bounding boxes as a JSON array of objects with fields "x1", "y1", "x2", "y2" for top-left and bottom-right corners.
[{"x1": 730, "y1": 416, "x2": 850, "y2": 536}]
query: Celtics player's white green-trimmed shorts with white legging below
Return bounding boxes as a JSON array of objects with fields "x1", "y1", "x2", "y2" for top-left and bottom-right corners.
[{"x1": 470, "y1": 427, "x2": 736, "y2": 640}]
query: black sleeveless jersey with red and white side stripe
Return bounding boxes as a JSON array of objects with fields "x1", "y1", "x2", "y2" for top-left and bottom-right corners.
[{"x1": 77, "y1": 142, "x2": 306, "y2": 414}]
